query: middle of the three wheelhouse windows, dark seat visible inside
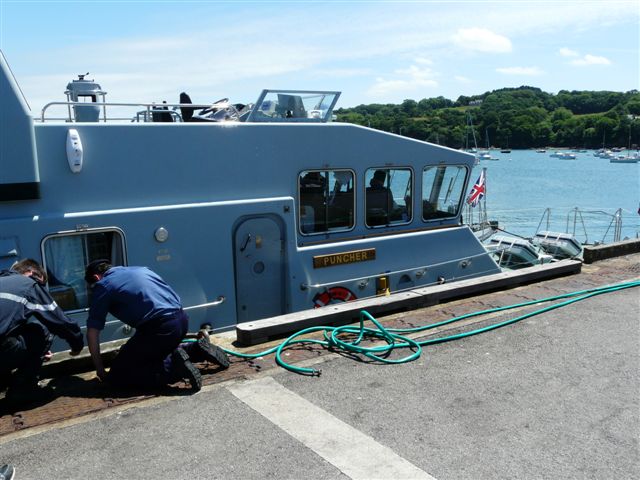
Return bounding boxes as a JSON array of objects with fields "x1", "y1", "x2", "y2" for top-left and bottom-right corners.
[{"x1": 365, "y1": 168, "x2": 413, "y2": 227}]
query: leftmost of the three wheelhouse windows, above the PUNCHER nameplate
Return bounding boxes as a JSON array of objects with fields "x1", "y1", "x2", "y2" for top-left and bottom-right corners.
[{"x1": 298, "y1": 170, "x2": 355, "y2": 235}]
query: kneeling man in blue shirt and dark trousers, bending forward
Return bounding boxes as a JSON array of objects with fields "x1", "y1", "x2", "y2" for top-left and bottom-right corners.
[{"x1": 85, "y1": 260, "x2": 229, "y2": 391}]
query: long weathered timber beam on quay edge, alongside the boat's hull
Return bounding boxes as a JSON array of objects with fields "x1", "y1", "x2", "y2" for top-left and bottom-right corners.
[{"x1": 236, "y1": 260, "x2": 582, "y2": 346}]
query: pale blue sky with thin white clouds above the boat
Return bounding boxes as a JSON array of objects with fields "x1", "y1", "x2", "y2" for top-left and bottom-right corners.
[{"x1": 0, "y1": 0, "x2": 640, "y2": 115}]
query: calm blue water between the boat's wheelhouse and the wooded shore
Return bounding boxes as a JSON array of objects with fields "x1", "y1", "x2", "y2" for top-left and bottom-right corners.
[{"x1": 471, "y1": 150, "x2": 640, "y2": 243}]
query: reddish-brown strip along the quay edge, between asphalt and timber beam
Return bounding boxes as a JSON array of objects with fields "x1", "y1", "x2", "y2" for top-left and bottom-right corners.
[{"x1": 0, "y1": 253, "x2": 640, "y2": 443}]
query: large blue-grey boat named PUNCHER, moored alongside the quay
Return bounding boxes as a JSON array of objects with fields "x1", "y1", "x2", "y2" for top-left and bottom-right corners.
[{"x1": 0, "y1": 50, "x2": 510, "y2": 349}]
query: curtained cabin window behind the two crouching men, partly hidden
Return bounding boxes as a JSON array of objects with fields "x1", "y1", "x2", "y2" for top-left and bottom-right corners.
[{"x1": 43, "y1": 230, "x2": 124, "y2": 311}]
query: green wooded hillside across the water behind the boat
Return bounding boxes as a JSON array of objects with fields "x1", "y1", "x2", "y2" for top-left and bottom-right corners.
[{"x1": 335, "y1": 86, "x2": 640, "y2": 148}]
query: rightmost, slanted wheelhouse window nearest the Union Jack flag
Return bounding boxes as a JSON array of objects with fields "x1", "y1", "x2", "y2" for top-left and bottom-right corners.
[{"x1": 422, "y1": 165, "x2": 467, "y2": 220}]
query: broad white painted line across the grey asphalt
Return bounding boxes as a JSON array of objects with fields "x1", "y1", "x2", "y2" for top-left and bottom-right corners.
[{"x1": 227, "y1": 377, "x2": 435, "y2": 480}]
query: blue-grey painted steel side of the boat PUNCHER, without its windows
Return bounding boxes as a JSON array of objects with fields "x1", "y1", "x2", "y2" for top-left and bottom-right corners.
[{"x1": 0, "y1": 52, "x2": 500, "y2": 348}]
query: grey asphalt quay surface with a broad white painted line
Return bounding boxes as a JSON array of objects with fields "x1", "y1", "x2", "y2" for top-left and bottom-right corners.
[{"x1": 0, "y1": 255, "x2": 640, "y2": 480}]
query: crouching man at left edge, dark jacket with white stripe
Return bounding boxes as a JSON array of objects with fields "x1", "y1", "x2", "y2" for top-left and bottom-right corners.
[{"x1": 0, "y1": 259, "x2": 84, "y2": 403}]
